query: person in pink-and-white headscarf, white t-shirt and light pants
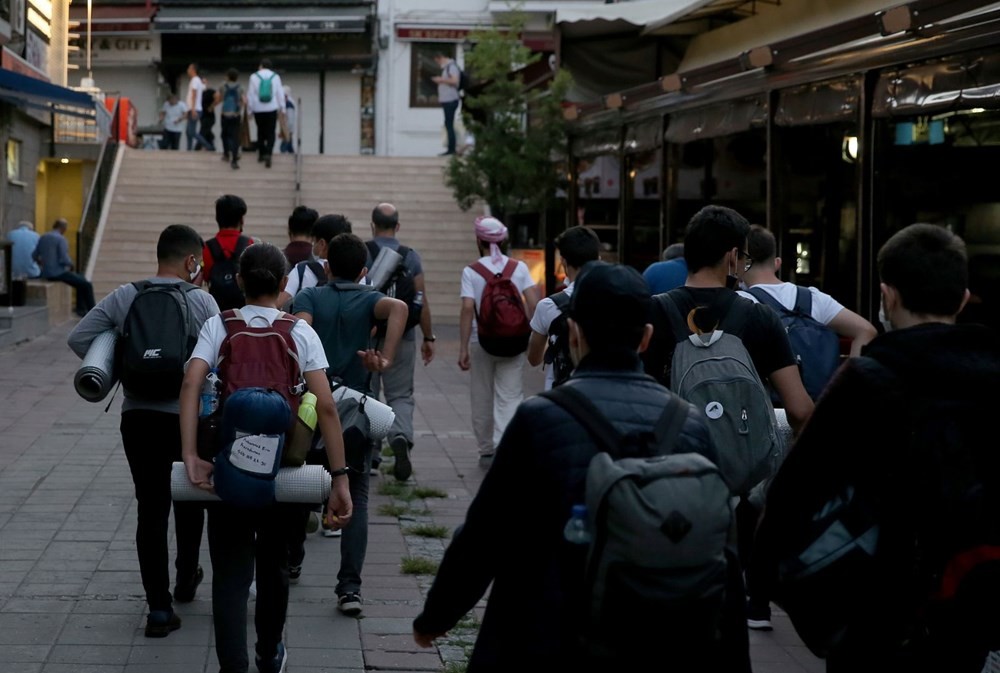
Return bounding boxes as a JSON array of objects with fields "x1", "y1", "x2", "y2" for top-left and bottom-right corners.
[{"x1": 458, "y1": 217, "x2": 539, "y2": 463}]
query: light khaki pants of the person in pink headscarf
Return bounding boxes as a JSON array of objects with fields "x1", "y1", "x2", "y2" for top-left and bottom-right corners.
[{"x1": 469, "y1": 343, "x2": 525, "y2": 456}]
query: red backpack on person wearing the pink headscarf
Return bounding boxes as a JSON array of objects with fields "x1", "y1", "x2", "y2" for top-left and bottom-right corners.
[{"x1": 469, "y1": 259, "x2": 531, "y2": 357}]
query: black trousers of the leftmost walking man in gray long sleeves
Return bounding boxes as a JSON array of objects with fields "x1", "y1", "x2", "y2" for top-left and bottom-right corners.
[{"x1": 121, "y1": 409, "x2": 205, "y2": 610}]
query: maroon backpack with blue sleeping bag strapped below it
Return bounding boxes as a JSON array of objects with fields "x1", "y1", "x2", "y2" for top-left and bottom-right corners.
[{"x1": 219, "y1": 309, "x2": 302, "y2": 422}]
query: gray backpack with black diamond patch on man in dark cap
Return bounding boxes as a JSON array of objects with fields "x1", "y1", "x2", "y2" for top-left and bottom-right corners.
[{"x1": 542, "y1": 385, "x2": 732, "y2": 659}]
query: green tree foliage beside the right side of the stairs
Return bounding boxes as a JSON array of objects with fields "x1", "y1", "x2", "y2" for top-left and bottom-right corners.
[{"x1": 445, "y1": 14, "x2": 571, "y2": 219}]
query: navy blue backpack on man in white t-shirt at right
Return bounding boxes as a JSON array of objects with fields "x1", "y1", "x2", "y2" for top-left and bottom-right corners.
[{"x1": 747, "y1": 286, "x2": 840, "y2": 400}]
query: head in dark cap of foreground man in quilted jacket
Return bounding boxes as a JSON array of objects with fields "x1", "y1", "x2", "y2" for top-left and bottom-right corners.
[{"x1": 569, "y1": 262, "x2": 652, "y2": 349}]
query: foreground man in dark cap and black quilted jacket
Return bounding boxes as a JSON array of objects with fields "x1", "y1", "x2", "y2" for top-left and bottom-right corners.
[{"x1": 413, "y1": 262, "x2": 728, "y2": 673}]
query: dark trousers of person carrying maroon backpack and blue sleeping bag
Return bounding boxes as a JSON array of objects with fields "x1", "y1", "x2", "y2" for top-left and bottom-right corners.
[{"x1": 208, "y1": 503, "x2": 294, "y2": 673}]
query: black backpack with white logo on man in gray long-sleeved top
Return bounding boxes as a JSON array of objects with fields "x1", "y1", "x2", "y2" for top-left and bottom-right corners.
[{"x1": 117, "y1": 281, "x2": 201, "y2": 400}]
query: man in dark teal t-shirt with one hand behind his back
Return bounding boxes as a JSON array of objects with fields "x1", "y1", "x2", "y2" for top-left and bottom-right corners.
[{"x1": 289, "y1": 234, "x2": 407, "y2": 616}]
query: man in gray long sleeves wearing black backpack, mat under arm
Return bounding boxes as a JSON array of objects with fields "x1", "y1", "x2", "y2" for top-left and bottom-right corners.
[{"x1": 69, "y1": 224, "x2": 219, "y2": 638}]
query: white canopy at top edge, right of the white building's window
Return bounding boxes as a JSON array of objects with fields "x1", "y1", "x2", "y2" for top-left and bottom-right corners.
[{"x1": 556, "y1": 0, "x2": 712, "y2": 37}]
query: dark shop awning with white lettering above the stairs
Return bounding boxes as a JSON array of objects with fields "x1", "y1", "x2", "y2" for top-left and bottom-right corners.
[{"x1": 153, "y1": 5, "x2": 368, "y2": 36}]
